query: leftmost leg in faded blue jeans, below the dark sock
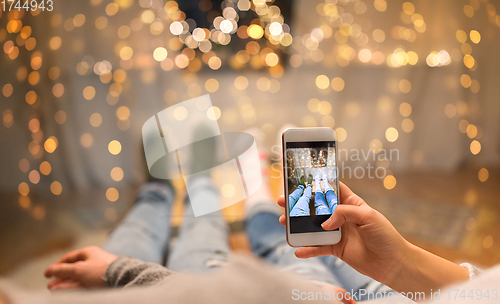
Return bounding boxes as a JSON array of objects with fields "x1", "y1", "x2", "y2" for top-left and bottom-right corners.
[{"x1": 102, "y1": 182, "x2": 174, "y2": 264}]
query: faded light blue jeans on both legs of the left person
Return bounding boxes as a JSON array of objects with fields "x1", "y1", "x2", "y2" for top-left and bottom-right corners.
[{"x1": 103, "y1": 177, "x2": 230, "y2": 273}]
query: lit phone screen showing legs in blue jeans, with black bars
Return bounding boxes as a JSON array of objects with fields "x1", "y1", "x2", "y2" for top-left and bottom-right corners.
[{"x1": 285, "y1": 141, "x2": 338, "y2": 233}]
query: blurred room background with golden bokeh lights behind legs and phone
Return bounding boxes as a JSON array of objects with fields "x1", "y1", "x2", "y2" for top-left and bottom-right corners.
[{"x1": 0, "y1": 0, "x2": 500, "y2": 288}]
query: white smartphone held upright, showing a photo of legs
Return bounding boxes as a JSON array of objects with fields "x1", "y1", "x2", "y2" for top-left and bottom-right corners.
[{"x1": 282, "y1": 128, "x2": 341, "y2": 247}]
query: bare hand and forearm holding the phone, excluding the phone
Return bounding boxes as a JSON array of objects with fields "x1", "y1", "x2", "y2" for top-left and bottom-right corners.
[{"x1": 278, "y1": 182, "x2": 469, "y2": 293}]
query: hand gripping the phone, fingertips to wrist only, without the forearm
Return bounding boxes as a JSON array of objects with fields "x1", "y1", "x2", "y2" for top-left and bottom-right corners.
[{"x1": 278, "y1": 182, "x2": 413, "y2": 286}]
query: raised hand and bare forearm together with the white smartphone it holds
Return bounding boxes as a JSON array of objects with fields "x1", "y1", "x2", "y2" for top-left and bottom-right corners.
[{"x1": 278, "y1": 132, "x2": 468, "y2": 293}]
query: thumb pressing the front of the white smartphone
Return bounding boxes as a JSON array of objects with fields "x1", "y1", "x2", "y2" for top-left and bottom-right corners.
[{"x1": 321, "y1": 204, "x2": 373, "y2": 230}]
